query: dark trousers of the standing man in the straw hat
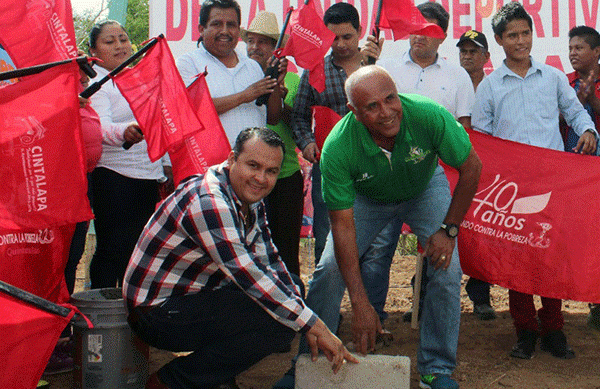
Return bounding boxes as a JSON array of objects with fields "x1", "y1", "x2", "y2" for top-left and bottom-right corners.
[{"x1": 265, "y1": 171, "x2": 304, "y2": 275}]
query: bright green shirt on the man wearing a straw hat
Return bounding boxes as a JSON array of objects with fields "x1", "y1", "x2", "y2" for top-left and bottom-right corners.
[{"x1": 267, "y1": 72, "x2": 300, "y2": 179}]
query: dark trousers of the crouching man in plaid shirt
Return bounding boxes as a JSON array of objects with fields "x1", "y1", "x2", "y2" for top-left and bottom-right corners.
[{"x1": 128, "y1": 286, "x2": 296, "y2": 389}]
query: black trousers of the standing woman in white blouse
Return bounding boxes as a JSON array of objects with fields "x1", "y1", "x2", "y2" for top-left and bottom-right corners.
[{"x1": 90, "y1": 168, "x2": 158, "y2": 289}]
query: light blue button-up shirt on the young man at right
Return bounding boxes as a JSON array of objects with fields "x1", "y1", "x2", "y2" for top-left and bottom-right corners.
[{"x1": 471, "y1": 59, "x2": 597, "y2": 151}]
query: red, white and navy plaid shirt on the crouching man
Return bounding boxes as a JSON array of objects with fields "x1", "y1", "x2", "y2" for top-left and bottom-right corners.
[{"x1": 123, "y1": 162, "x2": 317, "y2": 331}]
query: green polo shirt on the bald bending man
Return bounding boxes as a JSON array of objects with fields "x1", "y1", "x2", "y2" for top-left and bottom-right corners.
[{"x1": 320, "y1": 94, "x2": 471, "y2": 210}]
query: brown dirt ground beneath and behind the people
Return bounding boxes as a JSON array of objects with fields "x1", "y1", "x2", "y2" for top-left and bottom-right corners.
[{"x1": 48, "y1": 235, "x2": 600, "y2": 389}]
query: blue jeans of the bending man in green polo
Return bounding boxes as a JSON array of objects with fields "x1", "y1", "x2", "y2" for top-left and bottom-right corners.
[{"x1": 306, "y1": 166, "x2": 462, "y2": 374}]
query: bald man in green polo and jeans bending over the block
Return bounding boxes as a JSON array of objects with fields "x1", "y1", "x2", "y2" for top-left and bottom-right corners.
[{"x1": 306, "y1": 66, "x2": 481, "y2": 388}]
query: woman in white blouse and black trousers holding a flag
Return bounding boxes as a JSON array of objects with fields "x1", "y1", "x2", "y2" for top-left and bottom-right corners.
[{"x1": 89, "y1": 20, "x2": 171, "y2": 289}]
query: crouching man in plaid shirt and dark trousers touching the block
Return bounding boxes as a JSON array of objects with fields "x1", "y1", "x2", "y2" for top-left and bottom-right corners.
[{"x1": 123, "y1": 128, "x2": 357, "y2": 388}]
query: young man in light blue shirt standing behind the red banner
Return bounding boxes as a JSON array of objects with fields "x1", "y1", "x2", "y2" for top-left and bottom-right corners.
[{"x1": 471, "y1": 2, "x2": 598, "y2": 359}]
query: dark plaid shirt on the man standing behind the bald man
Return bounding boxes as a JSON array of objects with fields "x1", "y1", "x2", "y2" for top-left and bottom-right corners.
[{"x1": 292, "y1": 54, "x2": 350, "y2": 150}]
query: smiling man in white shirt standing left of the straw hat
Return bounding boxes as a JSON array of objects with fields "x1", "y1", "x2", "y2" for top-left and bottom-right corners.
[{"x1": 177, "y1": 0, "x2": 285, "y2": 145}]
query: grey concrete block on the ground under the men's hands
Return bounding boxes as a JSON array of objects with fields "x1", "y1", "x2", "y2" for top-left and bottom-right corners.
[{"x1": 295, "y1": 354, "x2": 410, "y2": 389}]
